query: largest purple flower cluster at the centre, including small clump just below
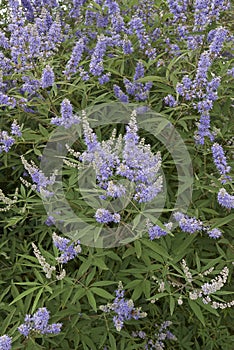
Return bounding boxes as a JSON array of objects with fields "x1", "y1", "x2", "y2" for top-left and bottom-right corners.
[{"x1": 79, "y1": 111, "x2": 162, "y2": 223}]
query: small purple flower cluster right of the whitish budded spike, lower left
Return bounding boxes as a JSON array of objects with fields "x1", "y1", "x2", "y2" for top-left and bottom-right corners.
[{"x1": 52, "y1": 232, "x2": 81, "y2": 264}]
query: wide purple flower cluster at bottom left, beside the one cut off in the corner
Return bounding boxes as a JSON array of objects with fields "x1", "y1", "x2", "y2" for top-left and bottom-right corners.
[{"x1": 18, "y1": 307, "x2": 62, "y2": 337}]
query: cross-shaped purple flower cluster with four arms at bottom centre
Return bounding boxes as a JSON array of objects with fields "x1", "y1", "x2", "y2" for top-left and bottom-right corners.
[{"x1": 100, "y1": 282, "x2": 147, "y2": 332}]
